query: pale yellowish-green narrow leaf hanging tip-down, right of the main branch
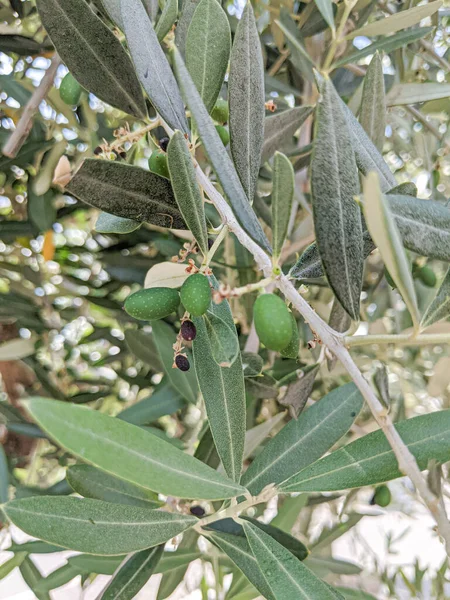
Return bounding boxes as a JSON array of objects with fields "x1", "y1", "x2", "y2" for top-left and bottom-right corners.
[{"x1": 364, "y1": 173, "x2": 420, "y2": 330}]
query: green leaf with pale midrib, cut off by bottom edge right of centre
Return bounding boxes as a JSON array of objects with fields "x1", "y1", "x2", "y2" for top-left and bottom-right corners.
[{"x1": 244, "y1": 522, "x2": 336, "y2": 600}]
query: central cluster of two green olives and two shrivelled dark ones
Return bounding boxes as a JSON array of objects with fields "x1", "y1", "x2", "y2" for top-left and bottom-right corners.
[{"x1": 124, "y1": 273, "x2": 212, "y2": 371}]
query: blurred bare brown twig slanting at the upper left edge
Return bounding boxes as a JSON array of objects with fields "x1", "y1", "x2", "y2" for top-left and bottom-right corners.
[{"x1": 3, "y1": 52, "x2": 61, "y2": 158}]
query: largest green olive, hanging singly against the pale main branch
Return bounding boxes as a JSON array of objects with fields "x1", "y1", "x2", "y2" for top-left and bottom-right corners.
[{"x1": 253, "y1": 294, "x2": 292, "y2": 352}]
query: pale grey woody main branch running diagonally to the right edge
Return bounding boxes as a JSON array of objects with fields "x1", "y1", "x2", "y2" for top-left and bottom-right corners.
[{"x1": 195, "y1": 164, "x2": 450, "y2": 556}]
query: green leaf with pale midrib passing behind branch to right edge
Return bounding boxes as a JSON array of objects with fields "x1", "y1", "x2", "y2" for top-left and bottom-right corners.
[{"x1": 280, "y1": 410, "x2": 450, "y2": 493}]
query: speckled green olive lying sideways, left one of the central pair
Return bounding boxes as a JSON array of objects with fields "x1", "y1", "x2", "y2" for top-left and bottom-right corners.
[{"x1": 124, "y1": 288, "x2": 180, "y2": 321}]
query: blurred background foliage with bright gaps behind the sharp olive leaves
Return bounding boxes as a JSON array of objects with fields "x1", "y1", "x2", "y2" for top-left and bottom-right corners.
[{"x1": 0, "y1": 0, "x2": 450, "y2": 599}]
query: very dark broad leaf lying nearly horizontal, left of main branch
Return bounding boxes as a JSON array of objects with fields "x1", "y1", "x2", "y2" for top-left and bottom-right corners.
[{"x1": 66, "y1": 159, "x2": 186, "y2": 229}]
